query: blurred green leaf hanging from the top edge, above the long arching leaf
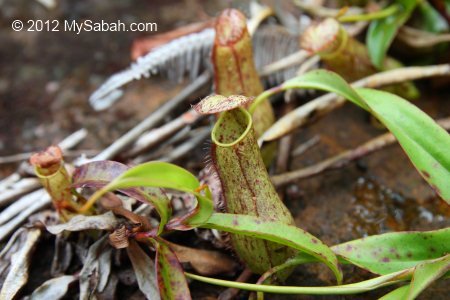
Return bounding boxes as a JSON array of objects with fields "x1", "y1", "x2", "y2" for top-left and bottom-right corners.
[{"x1": 366, "y1": 0, "x2": 417, "y2": 69}]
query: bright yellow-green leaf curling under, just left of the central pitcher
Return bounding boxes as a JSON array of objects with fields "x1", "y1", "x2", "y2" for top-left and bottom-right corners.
[{"x1": 89, "y1": 161, "x2": 213, "y2": 233}]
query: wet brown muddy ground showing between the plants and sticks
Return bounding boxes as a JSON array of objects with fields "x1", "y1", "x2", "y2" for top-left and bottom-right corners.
[{"x1": 0, "y1": 0, "x2": 450, "y2": 299}]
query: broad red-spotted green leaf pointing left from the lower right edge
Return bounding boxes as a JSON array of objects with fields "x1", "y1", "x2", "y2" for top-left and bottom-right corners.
[{"x1": 332, "y1": 228, "x2": 450, "y2": 275}]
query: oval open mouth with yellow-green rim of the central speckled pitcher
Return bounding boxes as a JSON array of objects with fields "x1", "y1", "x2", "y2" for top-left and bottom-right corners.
[{"x1": 211, "y1": 107, "x2": 253, "y2": 147}]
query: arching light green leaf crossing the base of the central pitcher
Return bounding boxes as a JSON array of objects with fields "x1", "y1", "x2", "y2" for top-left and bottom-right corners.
[{"x1": 202, "y1": 213, "x2": 342, "y2": 283}]
